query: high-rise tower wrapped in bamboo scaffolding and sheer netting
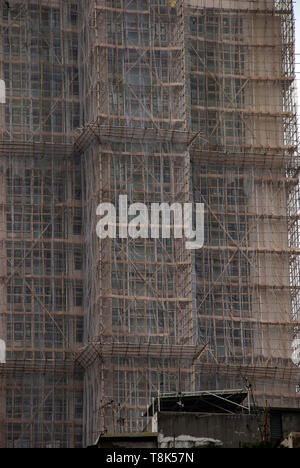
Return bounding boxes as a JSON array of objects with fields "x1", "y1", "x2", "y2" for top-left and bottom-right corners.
[{"x1": 0, "y1": 0, "x2": 300, "y2": 447}]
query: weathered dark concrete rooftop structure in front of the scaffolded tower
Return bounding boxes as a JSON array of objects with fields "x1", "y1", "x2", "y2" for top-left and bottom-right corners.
[{"x1": 98, "y1": 408, "x2": 300, "y2": 449}]
